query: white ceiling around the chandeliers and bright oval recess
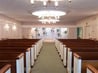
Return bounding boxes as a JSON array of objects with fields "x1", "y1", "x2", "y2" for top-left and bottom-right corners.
[{"x1": 0, "y1": 0, "x2": 98, "y2": 24}]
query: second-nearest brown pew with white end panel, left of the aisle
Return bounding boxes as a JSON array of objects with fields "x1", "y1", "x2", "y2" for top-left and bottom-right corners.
[{"x1": 0, "y1": 53, "x2": 24, "y2": 73}]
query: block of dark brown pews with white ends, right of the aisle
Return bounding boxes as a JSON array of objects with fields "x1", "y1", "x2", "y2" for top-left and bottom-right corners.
[{"x1": 55, "y1": 39, "x2": 98, "y2": 73}]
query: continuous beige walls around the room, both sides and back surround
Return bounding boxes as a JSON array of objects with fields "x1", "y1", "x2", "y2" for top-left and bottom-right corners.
[{"x1": 0, "y1": 14, "x2": 98, "y2": 40}]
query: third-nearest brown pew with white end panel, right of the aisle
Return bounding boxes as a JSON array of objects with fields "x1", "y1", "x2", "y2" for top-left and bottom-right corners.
[{"x1": 66, "y1": 47, "x2": 98, "y2": 73}]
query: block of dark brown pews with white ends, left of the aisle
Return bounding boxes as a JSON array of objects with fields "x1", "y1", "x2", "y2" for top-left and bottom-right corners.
[{"x1": 0, "y1": 39, "x2": 43, "y2": 73}]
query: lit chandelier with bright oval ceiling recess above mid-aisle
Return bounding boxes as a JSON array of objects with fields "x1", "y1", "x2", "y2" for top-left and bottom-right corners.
[{"x1": 32, "y1": 10, "x2": 66, "y2": 24}]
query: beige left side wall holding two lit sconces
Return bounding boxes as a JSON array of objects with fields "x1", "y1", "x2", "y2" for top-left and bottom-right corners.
[{"x1": 0, "y1": 14, "x2": 22, "y2": 39}]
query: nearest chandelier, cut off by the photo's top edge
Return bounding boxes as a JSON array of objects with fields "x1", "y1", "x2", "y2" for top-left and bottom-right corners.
[{"x1": 30, "y1": 0, "x2": 71, "y2": 6}]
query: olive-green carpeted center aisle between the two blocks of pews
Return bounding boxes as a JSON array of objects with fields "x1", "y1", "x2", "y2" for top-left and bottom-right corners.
[{"x1": 31, "y1": 43, "x2": 67, "y2": 73}]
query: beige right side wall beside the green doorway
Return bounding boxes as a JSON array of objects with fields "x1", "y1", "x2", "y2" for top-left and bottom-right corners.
[{"x1": 77, "y1": 15, "x2": 98, "y2": 40}]
